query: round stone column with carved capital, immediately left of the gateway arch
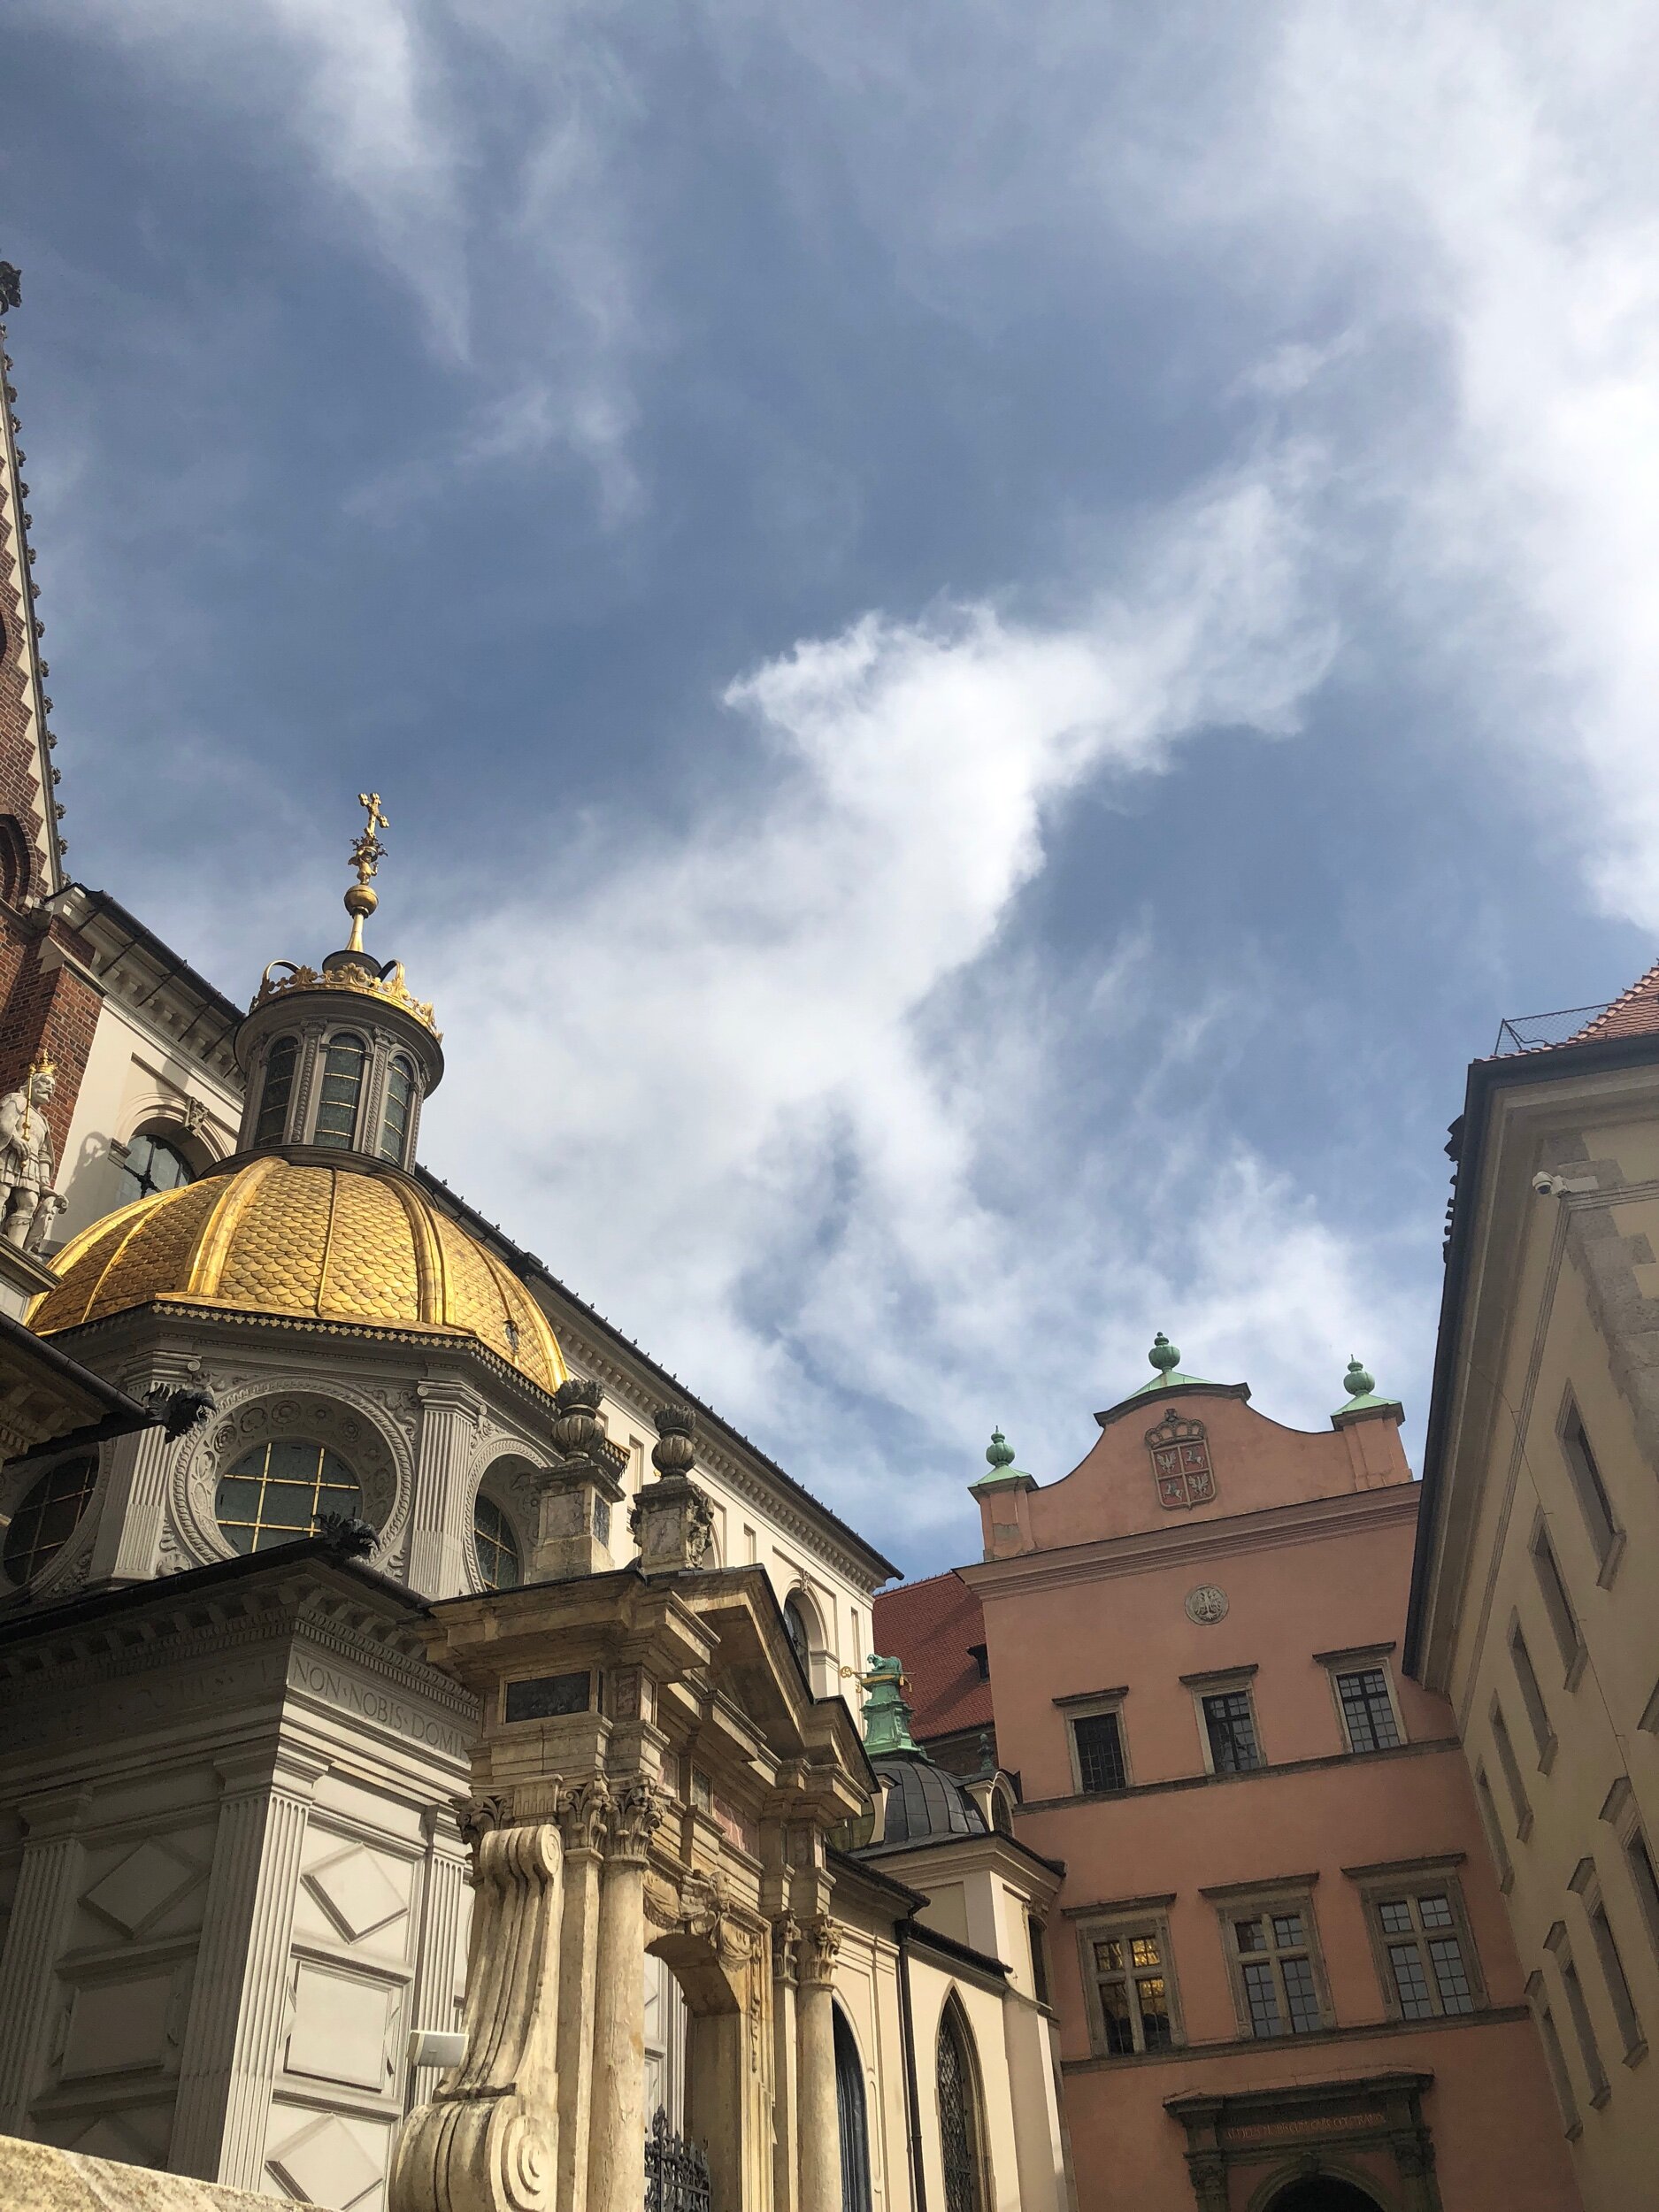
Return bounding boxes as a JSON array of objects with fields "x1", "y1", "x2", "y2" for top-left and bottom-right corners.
[{"x1": 587, "y1": 1774, "x2": 666, "y2": 2212}]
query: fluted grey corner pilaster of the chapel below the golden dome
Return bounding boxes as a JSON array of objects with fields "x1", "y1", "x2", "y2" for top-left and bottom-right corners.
[{"x1": 168, "y1": 1747, "x2": 327, "y2": 2190}]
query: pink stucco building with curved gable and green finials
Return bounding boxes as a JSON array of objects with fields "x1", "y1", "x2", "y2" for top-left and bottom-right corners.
[{"x1": 876, "y1": 1339, "x2": 1579, "y2": 2212}]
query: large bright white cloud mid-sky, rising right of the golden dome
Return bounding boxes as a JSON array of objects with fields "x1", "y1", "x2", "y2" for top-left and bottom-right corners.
[{"x1": 405, "y1": 451, "x2": 1383, "y2": 1542}]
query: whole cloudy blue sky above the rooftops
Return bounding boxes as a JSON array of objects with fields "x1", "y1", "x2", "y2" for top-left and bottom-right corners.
[{"x1": 0, "y1": 0, "x2": 1659, "y2": 1571}]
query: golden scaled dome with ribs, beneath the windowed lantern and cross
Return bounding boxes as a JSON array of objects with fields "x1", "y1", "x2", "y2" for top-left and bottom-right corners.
[{"x1": 29, "y1": 1153, "x2": 566, "y2": 1392}]
